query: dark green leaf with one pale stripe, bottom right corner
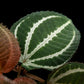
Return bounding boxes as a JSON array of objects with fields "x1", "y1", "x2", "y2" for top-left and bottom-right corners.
[{"x1": 47, "y1": 62, "x2": 84, "y2": 84}]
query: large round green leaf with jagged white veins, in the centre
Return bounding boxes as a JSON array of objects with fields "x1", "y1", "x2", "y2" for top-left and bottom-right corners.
[{"x1": 11, "y1": 11, "x2": 80, "y2": 70}]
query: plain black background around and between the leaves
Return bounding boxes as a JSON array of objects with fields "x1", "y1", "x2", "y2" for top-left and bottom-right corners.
[{"x1": 0, "y1": 1, "x2": 84, "y2": 79}]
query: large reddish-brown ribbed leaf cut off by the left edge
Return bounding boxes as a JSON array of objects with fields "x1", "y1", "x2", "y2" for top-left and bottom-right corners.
[{"x1": 0, "y1": 24, "x2": 20, "y2": 73}]
